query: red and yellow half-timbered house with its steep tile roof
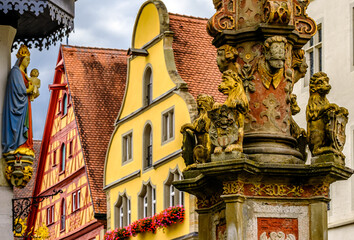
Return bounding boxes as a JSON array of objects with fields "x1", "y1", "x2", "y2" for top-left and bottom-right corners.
[{"x1": 29, "y1": 46, "x2": 126, "y2": 240}]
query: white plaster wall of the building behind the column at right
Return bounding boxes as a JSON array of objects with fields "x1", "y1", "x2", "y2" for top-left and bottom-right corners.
[{"x1": 294, "y1": 0, "x2": 354, "y2": 236}]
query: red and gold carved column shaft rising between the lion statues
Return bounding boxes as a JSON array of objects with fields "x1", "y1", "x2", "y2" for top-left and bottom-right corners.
[{"x1": 208, "y1": 0, "x2": 316, "y2": 163}]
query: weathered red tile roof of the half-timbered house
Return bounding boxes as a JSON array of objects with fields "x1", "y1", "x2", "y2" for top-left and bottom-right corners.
[{"x1": 62, "y1": 46, "x2": 127, "y2": 213}]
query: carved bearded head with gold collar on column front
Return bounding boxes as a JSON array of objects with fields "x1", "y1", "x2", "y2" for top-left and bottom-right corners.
[{"x1": 258, "y1": 36, "x2": 287, "y2": 89}]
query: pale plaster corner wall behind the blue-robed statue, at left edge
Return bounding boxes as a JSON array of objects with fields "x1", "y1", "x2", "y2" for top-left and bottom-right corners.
[{"x1": 0, "y1": 25, "x2": 16, "y2": 239}]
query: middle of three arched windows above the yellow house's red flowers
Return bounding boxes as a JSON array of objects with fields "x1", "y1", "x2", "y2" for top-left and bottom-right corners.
[{"x1": 138, "y1": 183, "x2": 156, "y2": 218}]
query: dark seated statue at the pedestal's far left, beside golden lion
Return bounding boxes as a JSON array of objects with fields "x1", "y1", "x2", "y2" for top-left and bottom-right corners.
[{"x1": 181, "y1": 94, "x2": 214, "y2": 166}]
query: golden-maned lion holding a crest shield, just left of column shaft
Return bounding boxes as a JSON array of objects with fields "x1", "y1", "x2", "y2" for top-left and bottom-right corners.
[{"x1": 208, "y1": 70, "x2": 249, "y2": 154}]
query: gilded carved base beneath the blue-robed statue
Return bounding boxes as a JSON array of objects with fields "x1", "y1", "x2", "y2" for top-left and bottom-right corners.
[{"x1": 3, "y1": 153, "x2": 35, "y2": 188}]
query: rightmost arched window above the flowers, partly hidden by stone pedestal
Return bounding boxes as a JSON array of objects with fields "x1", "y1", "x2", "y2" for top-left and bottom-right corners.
[{"x1": 164, "y1": 168, "x2": 184, "y2": 208}]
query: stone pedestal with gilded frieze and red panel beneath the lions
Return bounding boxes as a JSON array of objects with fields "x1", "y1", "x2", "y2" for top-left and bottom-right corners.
[{"x1": 174, "y1": 157, "x2": 353, "y2": 240}]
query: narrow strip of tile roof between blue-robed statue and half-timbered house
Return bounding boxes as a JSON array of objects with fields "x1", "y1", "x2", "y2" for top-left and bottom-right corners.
[{"x1": 14, "y1": 140, "x2": 42, "y2": 198}]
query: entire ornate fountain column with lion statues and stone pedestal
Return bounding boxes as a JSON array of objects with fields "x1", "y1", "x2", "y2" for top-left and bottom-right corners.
[{"x1": 174, "y1": 0, "x2": 353, "y2": 240}]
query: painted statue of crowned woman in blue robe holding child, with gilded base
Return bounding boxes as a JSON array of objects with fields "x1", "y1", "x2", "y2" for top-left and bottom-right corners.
[{"x1": 1, "y1": 45, "x2": 40, "y2": 187}]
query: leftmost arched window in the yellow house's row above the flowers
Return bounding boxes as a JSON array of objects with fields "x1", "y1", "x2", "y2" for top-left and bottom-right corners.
[{"x1": 114, "y1": 193, "x2": 131, "y2": 228}]
